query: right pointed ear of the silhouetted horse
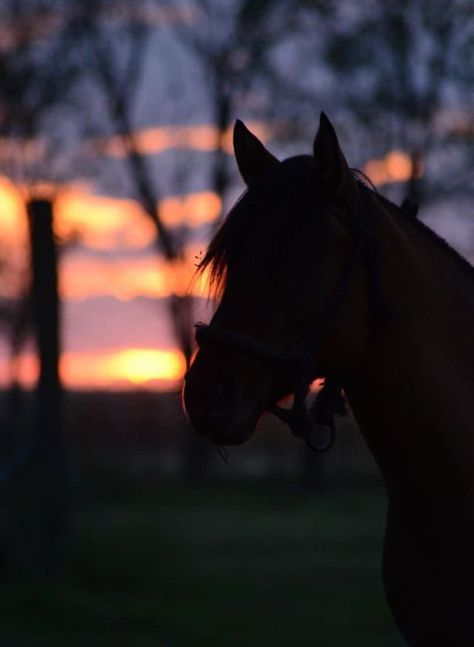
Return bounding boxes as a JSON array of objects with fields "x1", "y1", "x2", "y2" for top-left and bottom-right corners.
[{"x1": 313, "y1": 112, "x2": 352, "y2": 193}]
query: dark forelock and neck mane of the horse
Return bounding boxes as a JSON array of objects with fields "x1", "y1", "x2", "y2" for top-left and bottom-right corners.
[{"x1": 197, "y1": 155, "x2": 474, "y2": 297}]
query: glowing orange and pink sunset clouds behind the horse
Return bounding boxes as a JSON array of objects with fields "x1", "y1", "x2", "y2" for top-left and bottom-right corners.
[{"x1": 0, "y1": 124, "x2": 469, "y2": 389}]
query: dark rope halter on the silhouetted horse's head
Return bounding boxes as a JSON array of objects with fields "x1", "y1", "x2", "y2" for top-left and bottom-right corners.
[{"x1": 195, "y1": 187, "x2": 388, "y2": 452}]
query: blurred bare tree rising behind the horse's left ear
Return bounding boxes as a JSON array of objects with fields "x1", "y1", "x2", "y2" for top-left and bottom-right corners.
[{"x1": 175, "y1": 0, "x2": 300, "y2": 224}]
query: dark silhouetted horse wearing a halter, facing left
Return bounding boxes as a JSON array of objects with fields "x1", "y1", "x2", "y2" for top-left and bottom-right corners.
[{"x1": 183, "y1": 113, "x2": 474, "y2": 647}]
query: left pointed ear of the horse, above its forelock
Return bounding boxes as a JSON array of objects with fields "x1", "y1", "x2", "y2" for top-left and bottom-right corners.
[{"x1": 234, "y1": 119, "x2": 279, "y2": 186}]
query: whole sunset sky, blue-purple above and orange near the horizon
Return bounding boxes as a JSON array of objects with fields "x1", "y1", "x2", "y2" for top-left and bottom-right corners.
[{"x1": 0, "y1": 0, "x2": 474, "y2": 390}]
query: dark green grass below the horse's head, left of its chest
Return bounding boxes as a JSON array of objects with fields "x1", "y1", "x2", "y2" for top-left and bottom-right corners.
[{"x1": 0, "y1": 481, "x2": 403, "y2": 647}]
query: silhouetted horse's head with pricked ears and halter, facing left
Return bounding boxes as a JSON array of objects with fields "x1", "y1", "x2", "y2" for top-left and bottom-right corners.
[{"x1": 183, "y1": 113, "x2": 370, "y2": 445}]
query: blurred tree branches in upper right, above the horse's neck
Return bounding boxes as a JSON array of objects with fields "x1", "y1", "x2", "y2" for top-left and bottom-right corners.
[{"x1": 297, "y1": 0, "x2": 474, "y2": 200}]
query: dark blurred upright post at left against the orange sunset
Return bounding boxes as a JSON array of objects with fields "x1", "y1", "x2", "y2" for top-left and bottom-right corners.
[{"x1": 8, "y1": 200, "x2": 68, "y2": 577}]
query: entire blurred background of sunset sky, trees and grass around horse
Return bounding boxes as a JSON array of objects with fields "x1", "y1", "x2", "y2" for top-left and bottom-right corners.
[{"x1": 0, "y1": 0, "x2": 474, "y2": 647}]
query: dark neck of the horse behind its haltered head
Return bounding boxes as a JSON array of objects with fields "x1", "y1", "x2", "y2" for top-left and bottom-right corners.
[{"x1": 344, "y1": 202, "x2": 474, "y2": 502}]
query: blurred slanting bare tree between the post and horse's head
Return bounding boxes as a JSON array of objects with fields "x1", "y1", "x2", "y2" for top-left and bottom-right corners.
[{"x1": 76, "y1": 0, "x2": 198, "y2": 354}]
